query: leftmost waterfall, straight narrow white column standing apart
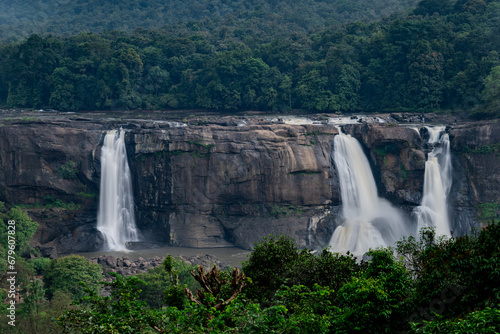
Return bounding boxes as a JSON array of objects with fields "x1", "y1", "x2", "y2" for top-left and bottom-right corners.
[{"x1": 97, "y1": 129, "x2": 139, "y2": 250}]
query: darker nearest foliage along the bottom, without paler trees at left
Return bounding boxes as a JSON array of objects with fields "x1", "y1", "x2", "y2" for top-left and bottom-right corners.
[{"x1": 56, "y1": 223, "x2": 500, "y2": 333}]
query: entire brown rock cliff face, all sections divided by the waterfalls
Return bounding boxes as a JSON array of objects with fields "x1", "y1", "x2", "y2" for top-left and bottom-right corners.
[{"x1": 0, "y1": 113, "x2": 500, "y2": 256}]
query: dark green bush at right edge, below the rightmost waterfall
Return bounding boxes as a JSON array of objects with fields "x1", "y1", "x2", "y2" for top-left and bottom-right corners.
[{"x1": 397, "y1": 222, "x2": 500, "y2": 321}]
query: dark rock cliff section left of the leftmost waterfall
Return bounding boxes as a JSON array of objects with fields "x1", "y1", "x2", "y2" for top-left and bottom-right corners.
[{"x1": 0, "y1": 121, "x2": 103, "y2": 255}]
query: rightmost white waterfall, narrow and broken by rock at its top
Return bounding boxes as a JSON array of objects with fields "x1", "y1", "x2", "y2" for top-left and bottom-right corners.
[{"x1": 413, "y1": 126, "x2": 452, "y2": 237}]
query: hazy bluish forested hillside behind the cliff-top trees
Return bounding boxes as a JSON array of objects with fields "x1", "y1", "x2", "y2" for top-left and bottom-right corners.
[{"x1": 0, "y1": 0, "x2": 417, "y2": 41}]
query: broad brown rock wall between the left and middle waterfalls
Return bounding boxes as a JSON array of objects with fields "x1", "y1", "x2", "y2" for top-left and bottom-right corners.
[{"x1": 129, "y1": 121, "x2": 339, "y2": 248}]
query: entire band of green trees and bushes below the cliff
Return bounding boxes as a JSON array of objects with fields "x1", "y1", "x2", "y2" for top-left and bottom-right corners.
[{"x1": 0, "y1": 197, "x2": 500, "y2": 334}]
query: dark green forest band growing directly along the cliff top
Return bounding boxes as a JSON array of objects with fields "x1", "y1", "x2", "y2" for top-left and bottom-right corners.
[{"x1": 0, "y1": 0, "x2": 500, "y2": 118}]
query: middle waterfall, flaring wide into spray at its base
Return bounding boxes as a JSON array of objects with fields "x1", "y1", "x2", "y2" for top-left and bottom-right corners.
[{"x1": 330, "y1": 132, "x2": 409, "y2": 256}]
